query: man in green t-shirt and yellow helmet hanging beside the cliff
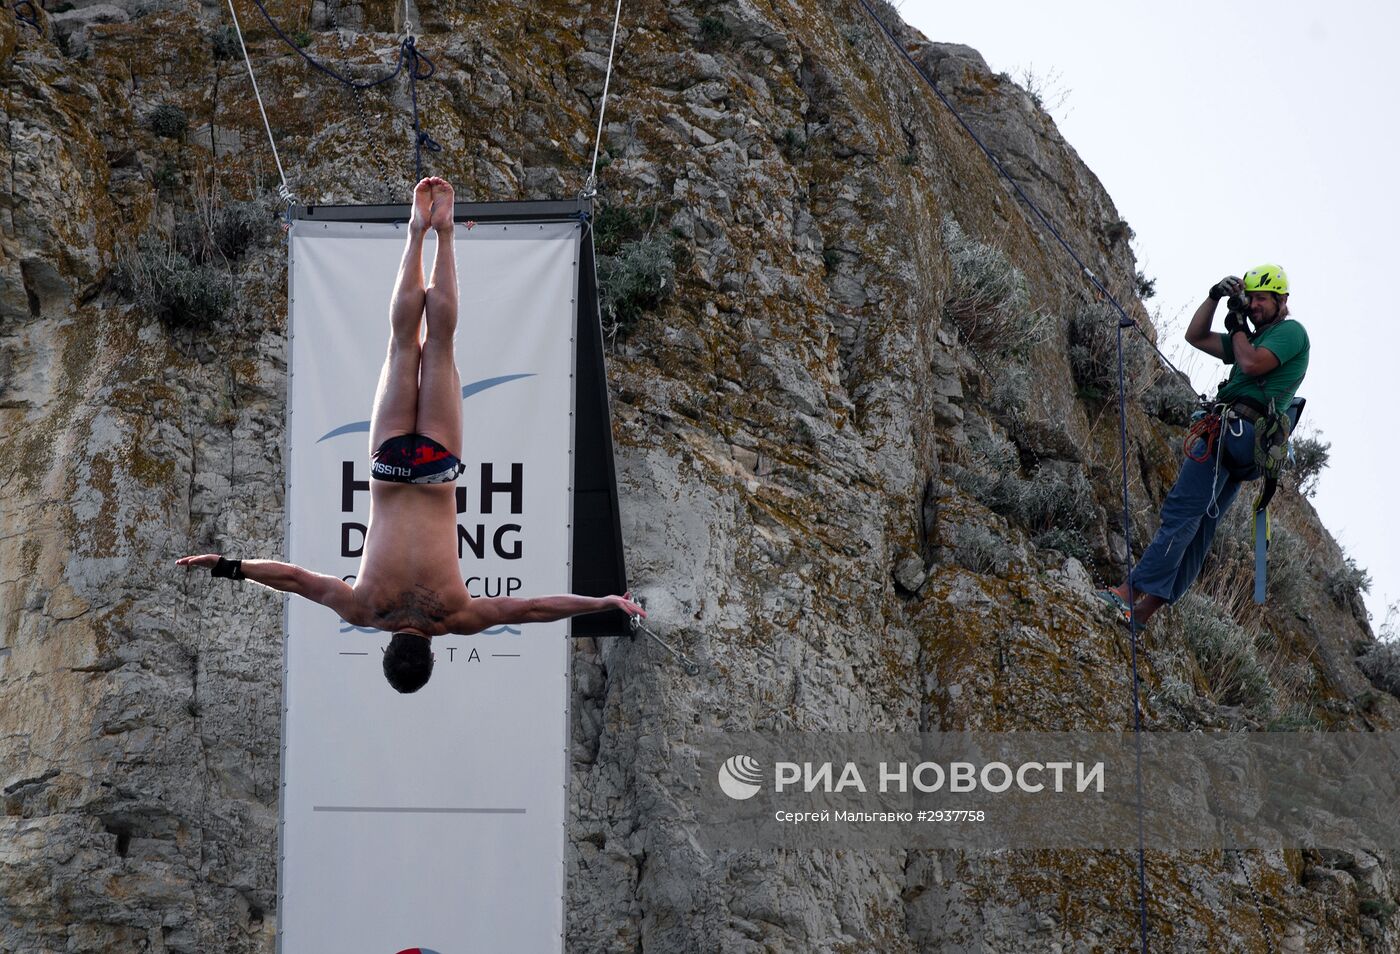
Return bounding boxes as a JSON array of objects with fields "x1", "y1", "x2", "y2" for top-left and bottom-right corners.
[{"x1": 1099, "y1": 265, "x2": 1309, "y2": 625}]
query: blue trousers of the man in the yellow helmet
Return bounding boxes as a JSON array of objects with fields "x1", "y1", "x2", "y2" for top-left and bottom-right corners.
[{"x1": 1130, "y1": 420, "x2": 1260, "y2": 602}]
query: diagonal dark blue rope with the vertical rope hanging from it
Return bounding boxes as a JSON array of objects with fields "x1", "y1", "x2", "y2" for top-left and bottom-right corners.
[{"x1": 860, "y1": 0, "x2": 1159, "y2": 954}]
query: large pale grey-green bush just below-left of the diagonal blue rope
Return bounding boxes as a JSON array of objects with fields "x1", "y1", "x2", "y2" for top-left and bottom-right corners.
[{"x1": 942, "y1": 216, "x2": 1051, "y2": 359}]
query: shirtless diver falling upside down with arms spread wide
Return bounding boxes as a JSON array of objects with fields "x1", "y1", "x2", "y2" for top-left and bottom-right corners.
[{"x1": 178, "y1": 177, "x2": 645, "y2": 692}]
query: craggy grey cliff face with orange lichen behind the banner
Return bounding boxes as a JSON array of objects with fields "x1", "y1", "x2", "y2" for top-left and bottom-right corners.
[{"x1": 0, "y1": 0, "x2": 1400, "y2": 954}]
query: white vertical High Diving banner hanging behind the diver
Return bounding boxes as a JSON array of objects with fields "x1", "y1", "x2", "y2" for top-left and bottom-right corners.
[{"x1": 279, "y1": 220, "x2": 581, "y2": 954}]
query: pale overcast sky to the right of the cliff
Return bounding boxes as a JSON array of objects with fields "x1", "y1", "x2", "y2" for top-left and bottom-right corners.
[{"x1": 895, "y1": 0, "x2": 1400, "y2": 626}]
